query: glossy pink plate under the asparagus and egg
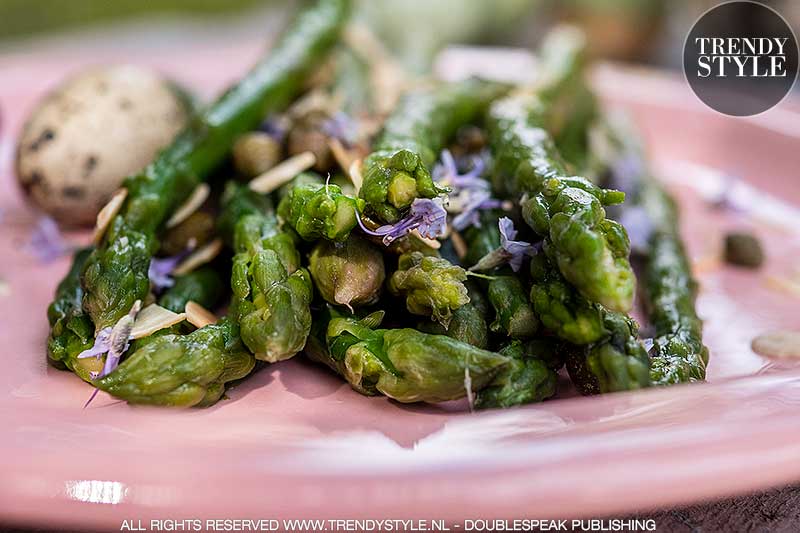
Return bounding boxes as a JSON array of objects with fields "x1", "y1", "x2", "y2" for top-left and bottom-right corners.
[{"x1": 0, "y1": 38, "x2": 800, "y2": 530}]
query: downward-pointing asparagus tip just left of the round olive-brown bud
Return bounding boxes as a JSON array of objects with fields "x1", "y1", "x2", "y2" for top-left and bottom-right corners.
[{"x1": 222, "y1": 184, "x2": 312, "y2": 363}]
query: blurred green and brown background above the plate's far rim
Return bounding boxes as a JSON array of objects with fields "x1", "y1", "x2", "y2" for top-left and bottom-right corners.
[{"x1": 0, "y1": 0, "x2": 800, "y2": 72}]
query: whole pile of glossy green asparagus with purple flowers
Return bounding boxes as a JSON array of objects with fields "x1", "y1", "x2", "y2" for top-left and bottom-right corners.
[{"x1": 43, "y1": 0, "x2": 707, "y2": 408}]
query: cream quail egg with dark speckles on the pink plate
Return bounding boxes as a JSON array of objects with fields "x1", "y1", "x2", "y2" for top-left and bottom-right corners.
[{"x1": 16, "y1": 65, "x2": 190, "y2": 226}]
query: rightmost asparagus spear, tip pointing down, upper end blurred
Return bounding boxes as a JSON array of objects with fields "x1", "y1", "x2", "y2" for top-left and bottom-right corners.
[{"x1": 642, "y1": 182, "x2": 708, "y2": 385}]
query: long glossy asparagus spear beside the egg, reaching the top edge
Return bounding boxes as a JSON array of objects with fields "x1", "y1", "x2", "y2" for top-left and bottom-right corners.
[{"x1": 82, "y1": 0, "x2": 349, "y2": 331}]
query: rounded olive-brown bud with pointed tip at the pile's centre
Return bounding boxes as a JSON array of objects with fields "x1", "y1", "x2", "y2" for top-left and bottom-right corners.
[{"x1": 309, "y1": 235, "x2": 386, "y2": 309}]
